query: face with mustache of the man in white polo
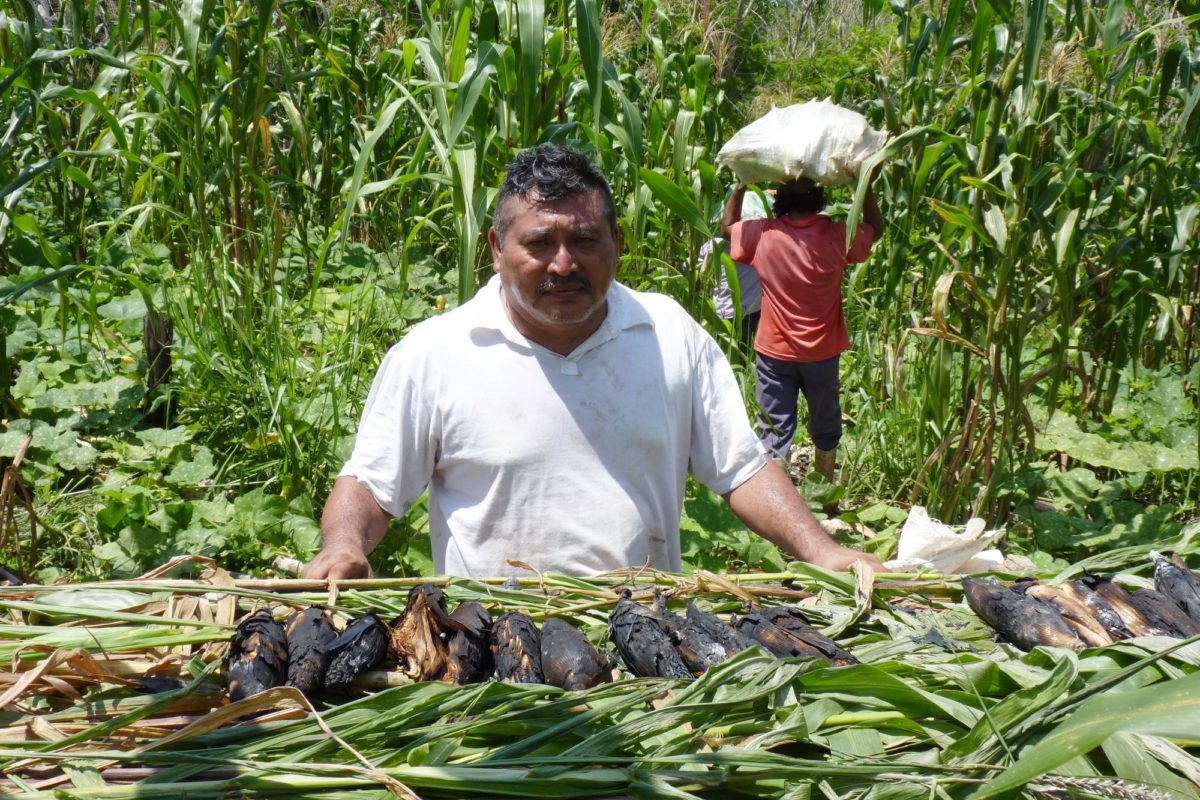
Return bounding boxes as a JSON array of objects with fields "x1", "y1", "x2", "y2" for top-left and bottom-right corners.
[{"x1": 488, "y1": 192, "x2": 619, "y2": 355}]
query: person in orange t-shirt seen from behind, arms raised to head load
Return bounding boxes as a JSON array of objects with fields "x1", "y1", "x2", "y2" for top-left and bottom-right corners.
[{"x1": 721, "y1": 175, "x2": 883, "y2": 481}]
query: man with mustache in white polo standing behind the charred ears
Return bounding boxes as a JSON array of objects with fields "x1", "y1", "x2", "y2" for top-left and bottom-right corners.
[{"x1": 305, "y1": 144, "x2": 880, "y2": 578}]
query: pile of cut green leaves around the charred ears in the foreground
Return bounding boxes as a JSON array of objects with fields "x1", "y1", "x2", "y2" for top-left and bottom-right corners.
[{"x1": 0, "y1": 563, "x2": 1200, "y2": 800}]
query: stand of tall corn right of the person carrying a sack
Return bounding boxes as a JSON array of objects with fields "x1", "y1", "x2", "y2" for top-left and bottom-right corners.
[{"x1": 844, "y1": 0, "x2": 1200, "y2": 515}]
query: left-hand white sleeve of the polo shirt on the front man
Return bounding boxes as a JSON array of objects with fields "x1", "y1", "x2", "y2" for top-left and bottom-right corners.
[{"x1": 338, "y1": 338, "x2": 440, "y2": 517}]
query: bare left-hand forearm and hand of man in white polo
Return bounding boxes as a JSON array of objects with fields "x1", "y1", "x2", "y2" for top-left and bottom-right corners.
[{"x1": 302, "y1": 476, "x2": 391, "y2": 579}]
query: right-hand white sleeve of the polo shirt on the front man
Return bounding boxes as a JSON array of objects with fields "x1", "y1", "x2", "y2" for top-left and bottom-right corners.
[{"x1": 689, "y1": 323, "x2": 767, "y2": 494}]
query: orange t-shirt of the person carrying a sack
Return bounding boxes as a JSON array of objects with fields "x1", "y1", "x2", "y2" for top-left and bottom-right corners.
[{"x1": 730, "y1": 213, "x2": 875, "y2": 362}]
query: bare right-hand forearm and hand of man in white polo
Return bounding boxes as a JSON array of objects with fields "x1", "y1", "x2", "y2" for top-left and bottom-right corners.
[{"x1": 725, "y1": 458, "x2": 883, "y2": 571}]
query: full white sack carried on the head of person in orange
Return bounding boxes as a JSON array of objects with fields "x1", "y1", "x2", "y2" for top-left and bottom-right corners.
[{"x1": 716, "y1": 100, "x2": 888, "y2": 186}]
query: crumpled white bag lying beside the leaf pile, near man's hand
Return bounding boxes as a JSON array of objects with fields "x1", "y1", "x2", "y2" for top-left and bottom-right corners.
[{"x1": 883, "y1": 506, "x2": 1016, "y2": 575}]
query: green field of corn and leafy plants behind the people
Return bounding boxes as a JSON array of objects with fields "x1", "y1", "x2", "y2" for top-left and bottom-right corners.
[{"x1": 0, "y1": 0, "x2": 1200, "y2": 581}]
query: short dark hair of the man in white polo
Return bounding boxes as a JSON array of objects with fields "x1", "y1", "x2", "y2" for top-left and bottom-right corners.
[{"x1": 492, "y1": 142, "x2": 617, "y2": 242}]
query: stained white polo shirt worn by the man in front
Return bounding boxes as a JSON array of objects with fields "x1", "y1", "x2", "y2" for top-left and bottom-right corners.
[{"x1": 341, "y1": 277, "x2": 766, "y2": 577}]
